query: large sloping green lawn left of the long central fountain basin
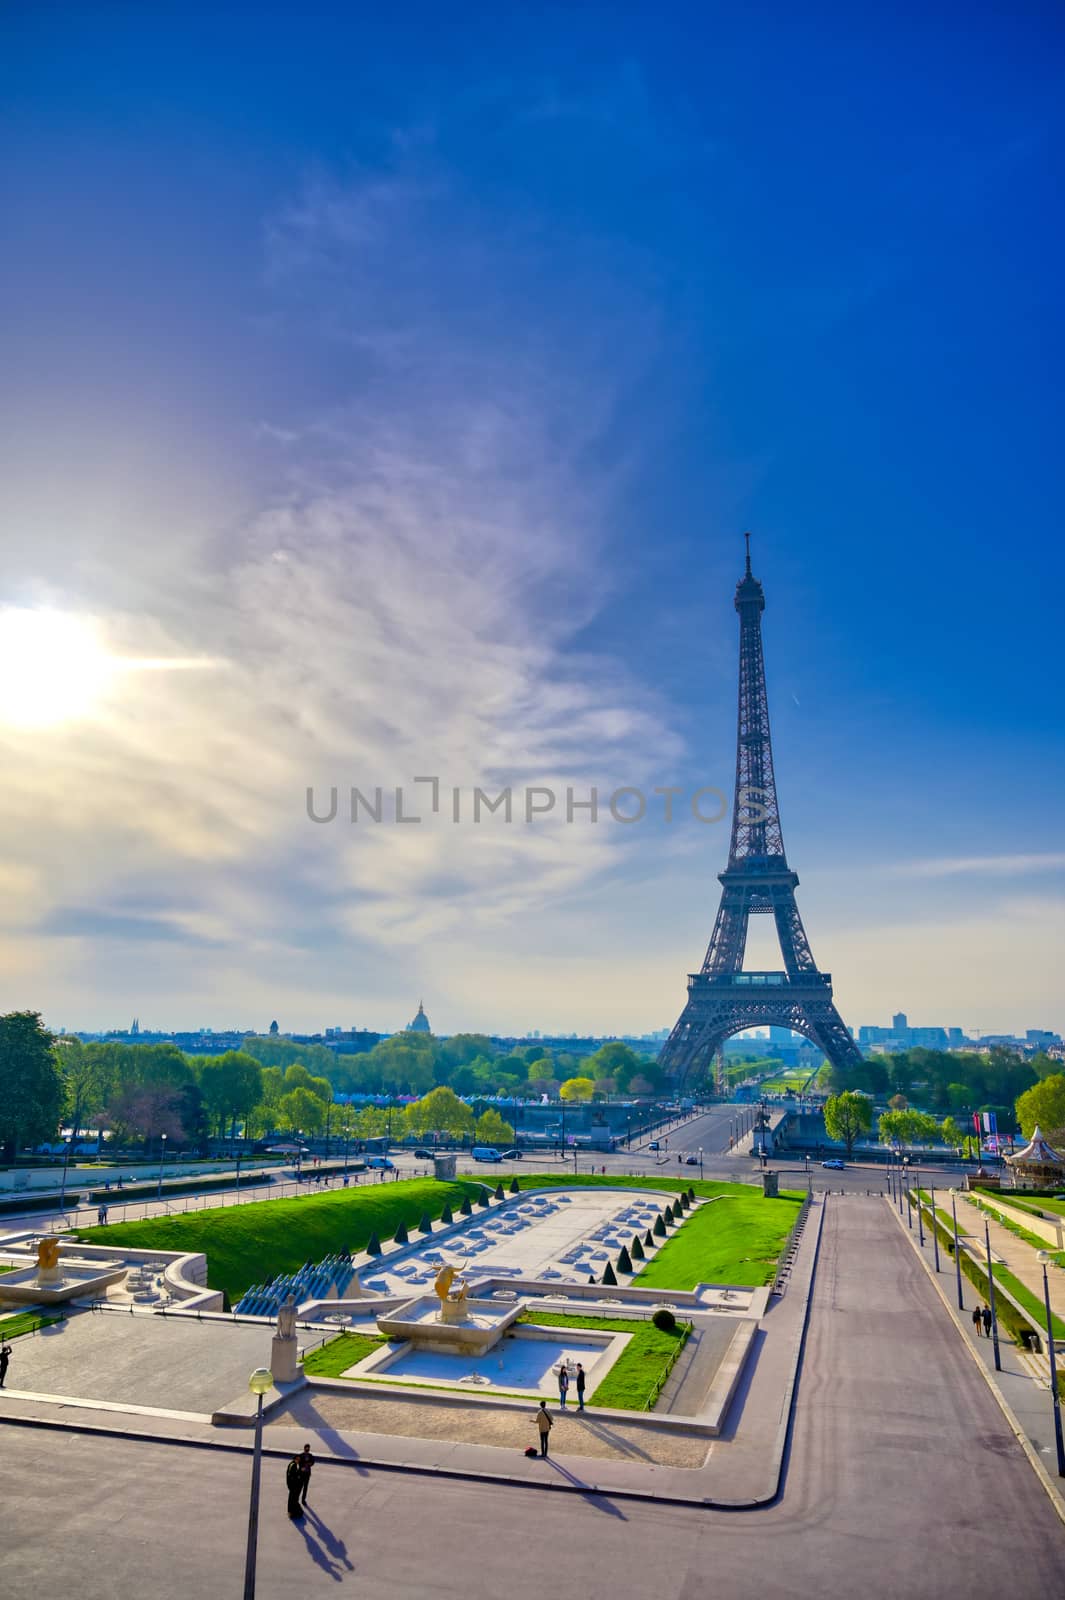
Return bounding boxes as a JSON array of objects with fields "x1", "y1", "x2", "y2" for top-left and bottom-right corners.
[{"x1": 77, "y1": 1178, "x2": 481, "y2": 1304}]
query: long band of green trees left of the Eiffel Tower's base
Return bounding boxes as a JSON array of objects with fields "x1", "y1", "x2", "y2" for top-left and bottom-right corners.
[{"x1": 0, "y1": 1011, "x2": 660, "y2": 1162}]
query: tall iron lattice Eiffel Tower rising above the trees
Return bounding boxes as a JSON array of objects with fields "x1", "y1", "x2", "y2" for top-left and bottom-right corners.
[{"x1": 659, "y1": 533, "x2": 862, "y2": 1085}]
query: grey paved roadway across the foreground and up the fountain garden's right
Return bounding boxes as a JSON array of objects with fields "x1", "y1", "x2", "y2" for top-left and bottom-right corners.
[{"x1": 0, "y1": 1195, "x2": 1065, "y2": 1600}]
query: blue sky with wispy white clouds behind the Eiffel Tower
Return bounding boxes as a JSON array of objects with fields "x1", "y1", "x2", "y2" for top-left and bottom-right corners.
[{"x1": 0, "y1": 5, "x2": 1065, "y2": 1030}]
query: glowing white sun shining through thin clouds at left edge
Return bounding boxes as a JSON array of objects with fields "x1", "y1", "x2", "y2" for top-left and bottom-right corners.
[{"x1": 0, "y1": 606, "x2": 118, "y2": 728}]
